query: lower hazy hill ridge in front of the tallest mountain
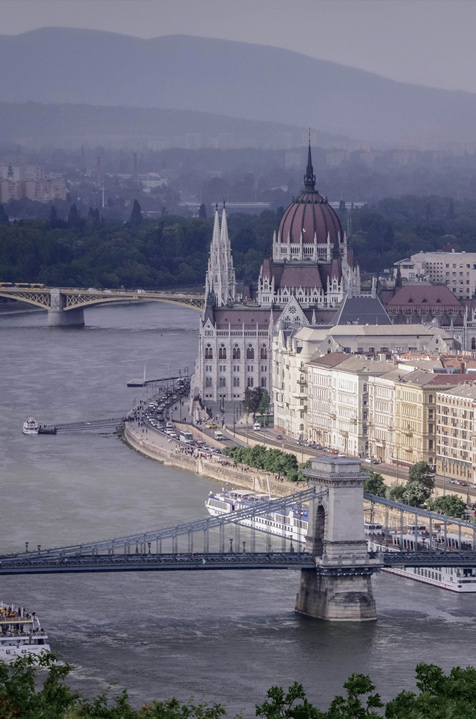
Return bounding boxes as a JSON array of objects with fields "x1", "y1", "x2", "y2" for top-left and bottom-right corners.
[{"x1": 0, "y1": 102, "x2": 357, "y2": 149}]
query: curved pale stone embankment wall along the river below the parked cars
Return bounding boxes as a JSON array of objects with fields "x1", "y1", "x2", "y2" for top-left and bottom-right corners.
[{"x1": 124, "y1": 422, "x2": 300, "y2": 497}]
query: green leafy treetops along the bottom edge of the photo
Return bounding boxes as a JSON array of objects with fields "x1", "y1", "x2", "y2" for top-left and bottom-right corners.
[{"x1": 0, "y1": 654, "x2": 476, "y2": 719}]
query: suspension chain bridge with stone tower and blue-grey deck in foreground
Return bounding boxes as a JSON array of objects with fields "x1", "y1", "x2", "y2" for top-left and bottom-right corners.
[{"x1": 0, "y1": 457, "x2": 476, "y2": 621}]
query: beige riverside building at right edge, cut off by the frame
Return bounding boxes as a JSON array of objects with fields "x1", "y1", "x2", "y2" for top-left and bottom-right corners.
[{"x1": 436, "y1": 382, "x2": 476, "y2": 483}]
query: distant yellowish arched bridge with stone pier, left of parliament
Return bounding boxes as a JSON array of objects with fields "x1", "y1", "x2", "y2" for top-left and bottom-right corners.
[{"x1": 0, "y1": 284, "x2": 205, "y2": 327}]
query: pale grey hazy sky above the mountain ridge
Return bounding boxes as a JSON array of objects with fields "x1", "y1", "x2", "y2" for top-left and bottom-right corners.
[{"x1": 0, "y1": 0, "x2": 476, "y2": 92}]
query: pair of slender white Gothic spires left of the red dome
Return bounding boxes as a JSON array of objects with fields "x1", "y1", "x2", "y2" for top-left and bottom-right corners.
[{"x1": 205, "y1": 206, "x2": 236, "y2": 307}]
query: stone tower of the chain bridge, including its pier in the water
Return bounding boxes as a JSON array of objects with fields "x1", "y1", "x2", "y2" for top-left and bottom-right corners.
[{"x1": 296, "y1": 457, "x2": 380, "y2": 622}]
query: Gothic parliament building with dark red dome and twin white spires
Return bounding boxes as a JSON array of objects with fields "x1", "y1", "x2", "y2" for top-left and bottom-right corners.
[{"x1": 191, "y1": 147, "x2": 360, "y2": 404}]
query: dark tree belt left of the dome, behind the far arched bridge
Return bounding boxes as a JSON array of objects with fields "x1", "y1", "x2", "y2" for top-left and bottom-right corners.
[{"x1": 0, "y1": 208, "x2": 282, "y2": 289}]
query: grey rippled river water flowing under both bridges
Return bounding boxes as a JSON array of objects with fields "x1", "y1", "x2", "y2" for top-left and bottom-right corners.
[{"x1": 0, "y1": 303, "x2": 476, "y2": 717}]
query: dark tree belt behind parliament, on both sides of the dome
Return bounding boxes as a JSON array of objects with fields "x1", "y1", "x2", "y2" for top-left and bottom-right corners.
[{"x1": 0, "y1": 197, "x2": 476, "y2": 289}]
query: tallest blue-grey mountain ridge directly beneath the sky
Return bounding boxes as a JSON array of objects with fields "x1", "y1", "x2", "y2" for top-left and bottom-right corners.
[{"x1": 0, "y1": 28, "x2": 476, "y2": 147}]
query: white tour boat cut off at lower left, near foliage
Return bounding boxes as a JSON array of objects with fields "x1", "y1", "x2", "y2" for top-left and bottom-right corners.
[{"x1": 0, "y1": 602, "x2": 51, "y2": 663}]
